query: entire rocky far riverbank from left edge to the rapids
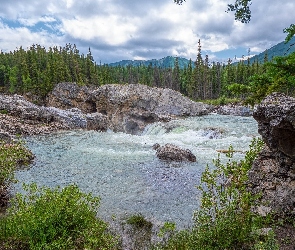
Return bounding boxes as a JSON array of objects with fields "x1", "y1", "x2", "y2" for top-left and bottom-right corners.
[{"x1": 0, "y1": 83, "x2": 212, "y2": 138}]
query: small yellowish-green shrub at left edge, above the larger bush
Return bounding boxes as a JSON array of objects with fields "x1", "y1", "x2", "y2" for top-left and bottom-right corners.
[{"x1": 0, "y1": 142, "x2": 33, "y2": 187}]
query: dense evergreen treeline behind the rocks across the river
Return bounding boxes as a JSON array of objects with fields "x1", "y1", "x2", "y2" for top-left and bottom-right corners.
[{"x1": 0, "y1": 41, "x2": 295, "y2": 100}]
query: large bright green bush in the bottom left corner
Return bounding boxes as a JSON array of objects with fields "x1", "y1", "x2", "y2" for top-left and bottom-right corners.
[{"x1": 0, "y1": 184, "x2": 117, "y2": 250}]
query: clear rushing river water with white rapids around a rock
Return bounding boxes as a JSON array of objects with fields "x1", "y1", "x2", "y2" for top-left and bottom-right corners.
[{"x1": 15, "y1": 114, "x2": 258, "y2": 227}]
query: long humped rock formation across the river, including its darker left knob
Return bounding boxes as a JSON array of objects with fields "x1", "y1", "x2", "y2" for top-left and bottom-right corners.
[{"x1": 47, "y1": 83, "x2": 211, "y2": 134}]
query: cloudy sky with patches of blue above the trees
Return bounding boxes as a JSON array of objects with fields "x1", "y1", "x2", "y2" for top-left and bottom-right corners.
[{"x1": 0, "y1": 0, "x2": 295, "y2": 64}]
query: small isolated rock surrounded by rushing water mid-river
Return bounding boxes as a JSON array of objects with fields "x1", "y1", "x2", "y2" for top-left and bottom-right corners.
[{"x1": 153, "y1": 143, "x2": 196, "y2": 162}]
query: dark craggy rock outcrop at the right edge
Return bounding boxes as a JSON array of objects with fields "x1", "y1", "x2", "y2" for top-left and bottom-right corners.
[{"x1": 249, "y1": 93, "x2": 295, "y2": 217}]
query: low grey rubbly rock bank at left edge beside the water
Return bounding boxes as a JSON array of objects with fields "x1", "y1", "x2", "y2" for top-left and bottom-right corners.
[{"x1": 0, "y1": 95, "x2": 107, "y2": 137}]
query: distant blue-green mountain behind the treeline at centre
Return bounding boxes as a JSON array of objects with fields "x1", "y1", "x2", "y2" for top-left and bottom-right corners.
[{"x1": 108, "y1": 56, "x2": 193, "y2": 69}]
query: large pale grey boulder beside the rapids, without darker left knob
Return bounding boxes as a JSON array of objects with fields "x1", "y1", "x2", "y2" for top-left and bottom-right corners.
[{"x1": 88, "y1": 84, "x2": 211, "y2": 134}]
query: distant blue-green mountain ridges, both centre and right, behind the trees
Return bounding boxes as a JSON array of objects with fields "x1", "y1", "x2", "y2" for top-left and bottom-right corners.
[{"x1": 108, "y1": 37, "x2": 295, "y2": 69}]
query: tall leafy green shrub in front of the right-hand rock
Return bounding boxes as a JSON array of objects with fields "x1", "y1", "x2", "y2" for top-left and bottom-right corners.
[{"x1": 155, "y1": 139, "x2": 277, "y2": 250}]
